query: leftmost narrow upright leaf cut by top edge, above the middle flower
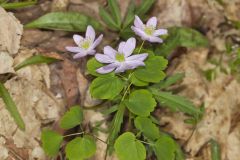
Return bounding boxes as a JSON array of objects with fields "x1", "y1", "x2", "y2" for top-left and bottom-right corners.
[{"x1": 108, "y1": 0, "x2": 122, "y2": 28}]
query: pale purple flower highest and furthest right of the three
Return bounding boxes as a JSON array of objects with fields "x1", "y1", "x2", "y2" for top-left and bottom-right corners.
[{"x1": 131, "y1": 16, "x2": 167, "y2": 43}]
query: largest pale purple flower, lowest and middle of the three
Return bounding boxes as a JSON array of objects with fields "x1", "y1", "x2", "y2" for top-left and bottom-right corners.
[{"x1": 95, "y1": 38, "x2": 148, "y2": 74}]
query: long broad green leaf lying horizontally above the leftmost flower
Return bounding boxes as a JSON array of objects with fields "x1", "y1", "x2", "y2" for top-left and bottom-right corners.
[{"x1": 25, "y1": 12, "x2": 102, "y2": 32}]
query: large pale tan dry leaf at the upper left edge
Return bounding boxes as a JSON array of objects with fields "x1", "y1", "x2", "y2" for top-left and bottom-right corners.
[{"x1": 0, "y1": 7, "x2": 23, "y2": 54}]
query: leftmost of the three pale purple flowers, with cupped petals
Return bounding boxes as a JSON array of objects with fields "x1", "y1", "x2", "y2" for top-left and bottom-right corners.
[{"x1": 66, "y1": 25, "x2": 103, "y2": 59}]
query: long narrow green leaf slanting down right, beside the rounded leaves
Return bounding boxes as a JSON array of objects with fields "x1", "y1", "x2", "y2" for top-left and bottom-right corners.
[{"x1": 151, "y1": 89, "x2": 202, "y2": 117}]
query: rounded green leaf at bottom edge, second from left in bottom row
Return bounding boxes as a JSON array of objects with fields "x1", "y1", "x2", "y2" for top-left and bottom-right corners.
[{"x1": 65, "y1": 136, "x2": 97, "y2": 160}]
